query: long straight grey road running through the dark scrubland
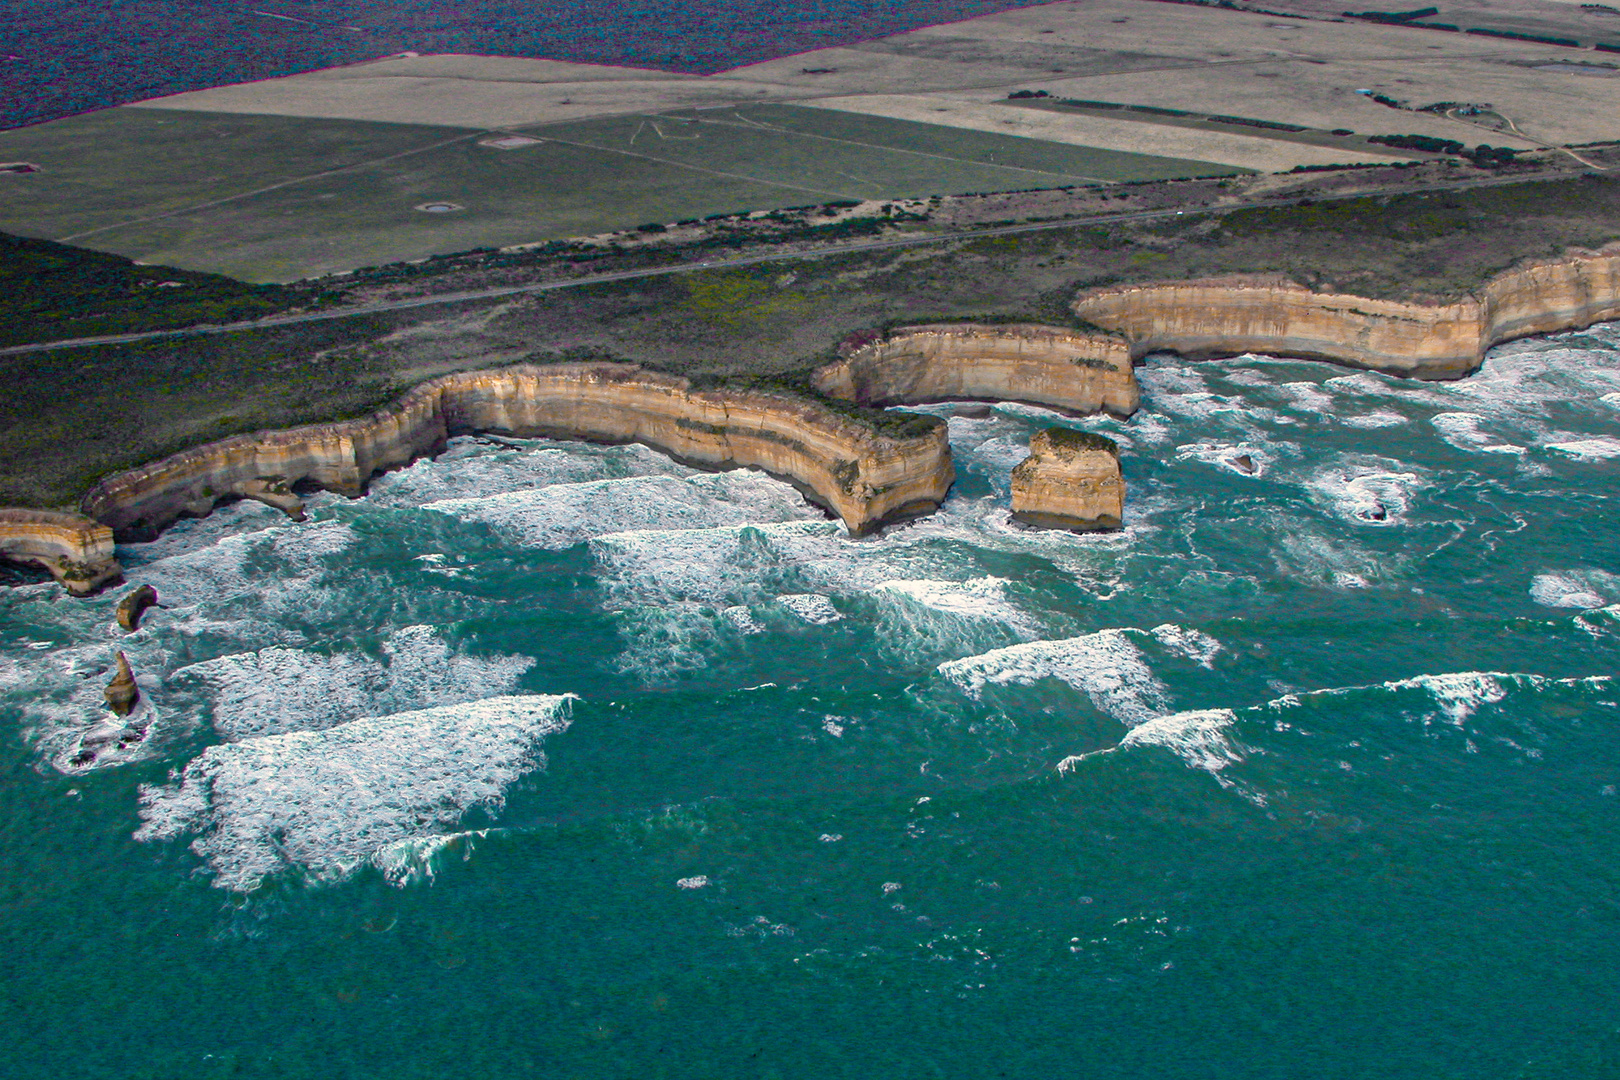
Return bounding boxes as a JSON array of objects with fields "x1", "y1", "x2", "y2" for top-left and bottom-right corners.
[{"x1": 0, "y1": 166, "x2": 1571, "y2": 356}]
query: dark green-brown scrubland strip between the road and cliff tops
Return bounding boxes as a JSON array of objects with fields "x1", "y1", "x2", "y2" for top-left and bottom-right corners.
[{"x1": 0, "y1": 159, "x2": 1620, "y2": 507}]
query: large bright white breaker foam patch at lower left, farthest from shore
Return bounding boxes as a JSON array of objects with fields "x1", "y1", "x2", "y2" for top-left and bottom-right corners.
[{"x1": 134, "y1": 695, "x2": 572, "y2": 892}]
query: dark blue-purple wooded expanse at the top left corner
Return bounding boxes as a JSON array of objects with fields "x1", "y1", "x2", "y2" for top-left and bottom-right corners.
[{"x1": 0, "y1": 0, "x2": 1025, "y2": 128}]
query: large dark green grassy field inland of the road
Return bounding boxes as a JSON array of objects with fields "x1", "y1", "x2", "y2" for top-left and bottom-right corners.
[{"x1": 0, "y1": 105, "x2": 1231, "y2": 282}]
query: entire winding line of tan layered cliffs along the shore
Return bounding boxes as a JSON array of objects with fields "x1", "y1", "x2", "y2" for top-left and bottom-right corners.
[{"x1": 0, "y1": 244, "x2": 1620, "y2": 594}]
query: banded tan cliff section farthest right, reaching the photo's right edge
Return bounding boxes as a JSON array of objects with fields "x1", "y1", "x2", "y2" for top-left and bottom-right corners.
[{"x1": 1074, "y1": 249, "x2": 1620, "y2": 379}]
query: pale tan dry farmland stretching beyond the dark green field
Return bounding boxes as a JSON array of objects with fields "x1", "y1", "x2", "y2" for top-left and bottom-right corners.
[{"x1": 143, "y1": 0, "x2": 1620, "y2": 170}]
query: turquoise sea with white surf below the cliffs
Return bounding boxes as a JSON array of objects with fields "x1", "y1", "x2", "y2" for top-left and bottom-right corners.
[{"x1": 0, "y1": 333, "x2": 1620, "y2": 1080}]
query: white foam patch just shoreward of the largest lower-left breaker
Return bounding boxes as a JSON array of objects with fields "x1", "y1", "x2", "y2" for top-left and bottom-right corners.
[{"x1": 173, "y1": 627, "x2": 535, "y2": 740}]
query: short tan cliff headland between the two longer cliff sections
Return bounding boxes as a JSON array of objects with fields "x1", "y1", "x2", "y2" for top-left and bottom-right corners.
[{"x1": 812, "y1": 324, "x2": 1139, "y2": 416}]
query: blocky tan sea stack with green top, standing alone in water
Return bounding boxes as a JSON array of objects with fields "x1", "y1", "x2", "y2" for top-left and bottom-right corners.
[{"x1": 1013, "y1": 427, "x2": 1124, "y2": 533}]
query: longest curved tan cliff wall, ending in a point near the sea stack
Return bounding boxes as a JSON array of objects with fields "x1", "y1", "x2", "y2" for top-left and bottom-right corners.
[{"x1": 84, "y1": 363, "x2": 956, "y2": 536}]
